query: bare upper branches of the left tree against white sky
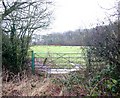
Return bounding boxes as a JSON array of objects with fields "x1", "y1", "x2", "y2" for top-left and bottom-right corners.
[{"x1": 2, "y1": 0, "x2": 52, "y2": 35}]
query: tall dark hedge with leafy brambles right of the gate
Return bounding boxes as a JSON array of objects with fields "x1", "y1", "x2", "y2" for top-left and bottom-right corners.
[{"x1": 50, "y1": 1, "x2": 120, "y2": 96}]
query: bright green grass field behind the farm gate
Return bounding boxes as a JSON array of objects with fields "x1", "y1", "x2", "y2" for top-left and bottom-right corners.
[{"x1": 30, "y1": 46, "x2": 86, "y2": 68}]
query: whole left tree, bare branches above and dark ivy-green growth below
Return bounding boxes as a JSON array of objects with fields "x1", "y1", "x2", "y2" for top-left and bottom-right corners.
[{"x1": 2, "y1": 0, "x2": 52, "y2": 74}]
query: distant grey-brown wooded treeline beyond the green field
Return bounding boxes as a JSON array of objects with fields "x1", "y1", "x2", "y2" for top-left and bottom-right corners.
[{"x1": 32, "y1": 23, "x2": 117, "y2": 46}]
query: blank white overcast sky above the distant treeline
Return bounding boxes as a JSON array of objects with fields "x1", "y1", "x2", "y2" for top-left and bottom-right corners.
[{"x1": 36, "y1": 0, "x2": 116, "y2": 34}]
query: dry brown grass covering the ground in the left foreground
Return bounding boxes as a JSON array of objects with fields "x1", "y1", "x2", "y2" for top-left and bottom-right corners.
[{"x1": 2, "y1": 71, "x2": 87, "y2": 96}]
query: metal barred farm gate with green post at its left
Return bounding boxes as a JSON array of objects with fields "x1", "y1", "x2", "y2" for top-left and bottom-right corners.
[{"x1": 31, "y1": 51, "x2": 86, "y2": 73}]
